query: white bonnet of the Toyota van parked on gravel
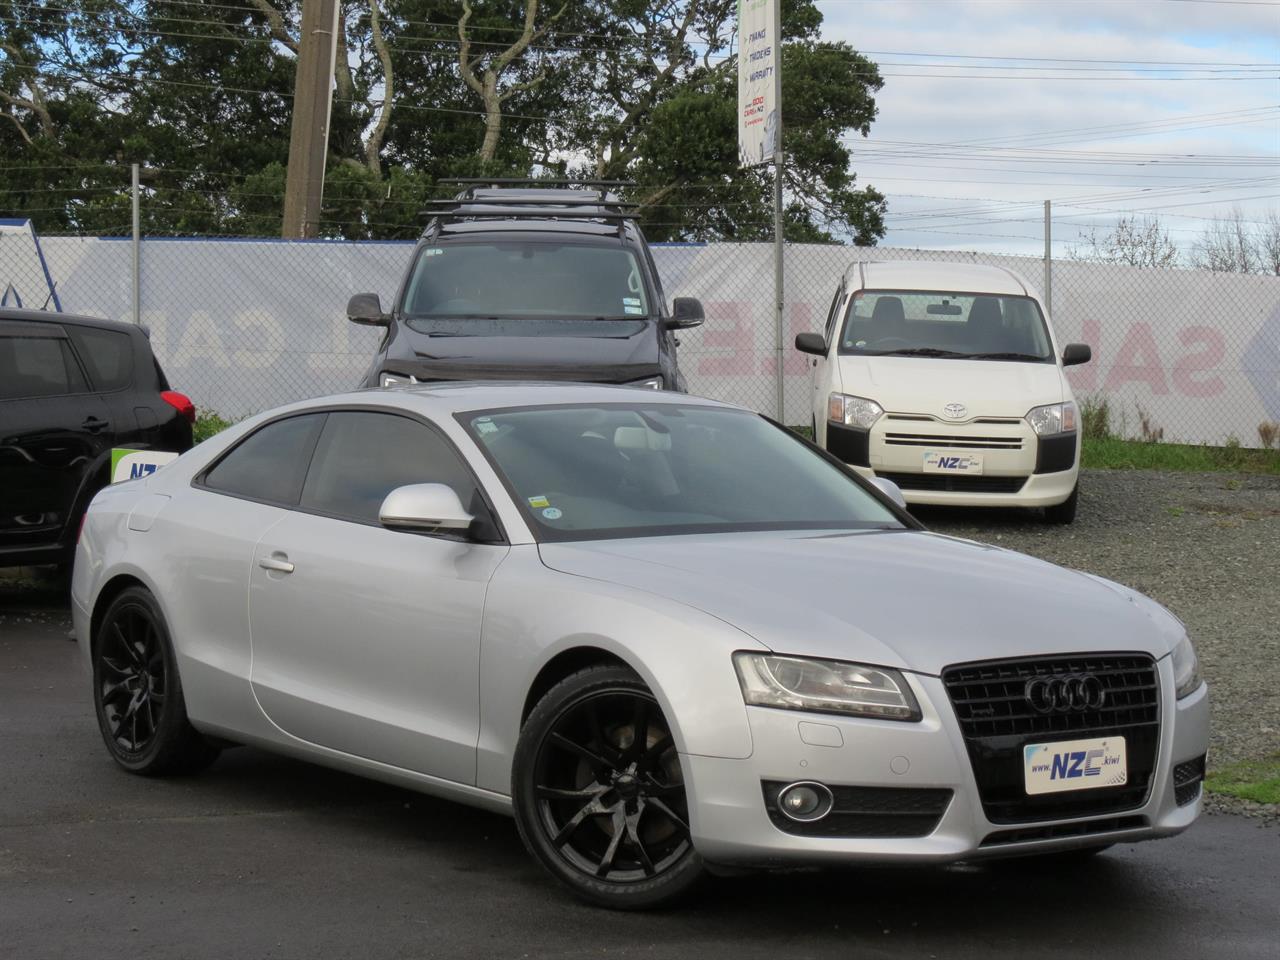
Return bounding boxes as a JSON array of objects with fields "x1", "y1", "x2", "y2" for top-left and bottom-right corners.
[{"x1": 840, "y1": 356, "x2": 1069, "y2": 417}]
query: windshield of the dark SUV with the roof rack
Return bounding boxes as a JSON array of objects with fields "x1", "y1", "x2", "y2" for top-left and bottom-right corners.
[{"x1": 402, "y1": 239, "x2": 649, "y2": 320}]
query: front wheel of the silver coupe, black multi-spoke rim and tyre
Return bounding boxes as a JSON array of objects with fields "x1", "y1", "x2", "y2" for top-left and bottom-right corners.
[{"x1": 512, "y1": 666, "x2": 704, "y2": 910}]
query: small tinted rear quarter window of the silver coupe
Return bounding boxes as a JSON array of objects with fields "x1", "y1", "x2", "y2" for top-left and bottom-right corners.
[{"x1": 204, "y1": 413, "x2": 325, "y2": 507}]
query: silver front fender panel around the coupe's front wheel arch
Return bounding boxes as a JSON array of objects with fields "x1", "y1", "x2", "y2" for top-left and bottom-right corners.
[{"x1": 476, "y1": 544, "x2": 764, "y2": 794}]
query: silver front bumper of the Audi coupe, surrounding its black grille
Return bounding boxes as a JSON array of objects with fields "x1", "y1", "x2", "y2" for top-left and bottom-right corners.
[{"x1": 681, "y1": 657, "x2": 1208, "y2": 867}]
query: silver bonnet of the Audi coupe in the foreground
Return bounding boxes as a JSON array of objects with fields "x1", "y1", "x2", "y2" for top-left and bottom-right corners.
[{"x1": 539, "y1": 531, "x2": 1180, "y2": 675}]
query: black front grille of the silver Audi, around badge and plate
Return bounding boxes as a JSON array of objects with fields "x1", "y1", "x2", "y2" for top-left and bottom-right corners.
[{"x1": 942, "y1": 653, "x2": 1160, "y2": 823}]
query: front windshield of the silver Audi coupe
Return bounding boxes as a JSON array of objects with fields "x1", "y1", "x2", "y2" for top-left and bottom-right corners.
[{"x1": 458, "y1": 403, "x2": 902, "y2": 540}]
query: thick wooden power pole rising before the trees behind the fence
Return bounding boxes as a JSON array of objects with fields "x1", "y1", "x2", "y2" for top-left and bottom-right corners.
[{"x1": 282, "y1": 0, "x2": 338, "y2": 239}]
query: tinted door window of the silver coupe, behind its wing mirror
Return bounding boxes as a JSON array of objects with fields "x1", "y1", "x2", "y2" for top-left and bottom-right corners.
[{"x1": 301, "y1": 411, "x2": 476, "y2": 524}]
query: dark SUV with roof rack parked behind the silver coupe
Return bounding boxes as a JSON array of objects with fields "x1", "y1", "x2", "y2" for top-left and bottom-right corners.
[{"x1": 347, "y1": 179, "x2": 703, "y2": 390}]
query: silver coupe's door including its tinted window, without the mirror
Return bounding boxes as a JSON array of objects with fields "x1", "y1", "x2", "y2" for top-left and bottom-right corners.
[{"x1": 248, "y1": 410, "x2": 508, "y2": 783}]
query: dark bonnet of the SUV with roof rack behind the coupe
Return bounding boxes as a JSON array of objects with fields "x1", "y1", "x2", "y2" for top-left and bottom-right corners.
[{"x1": 384, "y1": 319, "x2": 659, "y2": 383}]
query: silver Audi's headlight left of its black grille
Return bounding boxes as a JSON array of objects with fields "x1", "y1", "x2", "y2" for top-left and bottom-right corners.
[{"x1": 733, "y1": 650, "x2": 920, "y2": 721}]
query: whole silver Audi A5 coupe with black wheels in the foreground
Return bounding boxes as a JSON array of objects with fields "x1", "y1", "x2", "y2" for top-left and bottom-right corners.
[{"x1": 72, "y1": 383, "x2": 1208, "y2": 908}]
